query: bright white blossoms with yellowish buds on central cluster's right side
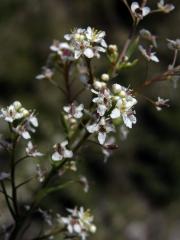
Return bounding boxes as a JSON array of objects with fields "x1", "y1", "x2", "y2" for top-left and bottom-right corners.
[{"x1": 110, "y1": 84, "x2": 137, "y2": 128}]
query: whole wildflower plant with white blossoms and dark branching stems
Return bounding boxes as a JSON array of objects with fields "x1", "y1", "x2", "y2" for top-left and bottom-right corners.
[{"x1": 0, "y1": 0, "x2": 180, "y2": 240}]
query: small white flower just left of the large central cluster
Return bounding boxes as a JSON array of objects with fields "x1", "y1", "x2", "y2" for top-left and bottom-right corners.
[{"x1": 63, "y1": 103, "x2": 84, "y2": 119}]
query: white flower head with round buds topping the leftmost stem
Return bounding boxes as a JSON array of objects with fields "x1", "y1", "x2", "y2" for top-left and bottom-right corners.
[{"x1": 0, "y1": 101, "x2": 26, "y2": 123}]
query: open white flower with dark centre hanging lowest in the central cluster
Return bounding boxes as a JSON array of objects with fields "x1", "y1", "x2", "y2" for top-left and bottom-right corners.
[{"x1": 87, "y1": 117, "x2": 114, "y2": 145}]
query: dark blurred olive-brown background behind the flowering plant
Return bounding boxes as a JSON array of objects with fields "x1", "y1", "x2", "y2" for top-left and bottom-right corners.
[{"x1": 0, "y1": 0, "x2": 180, "y2": 240}]
